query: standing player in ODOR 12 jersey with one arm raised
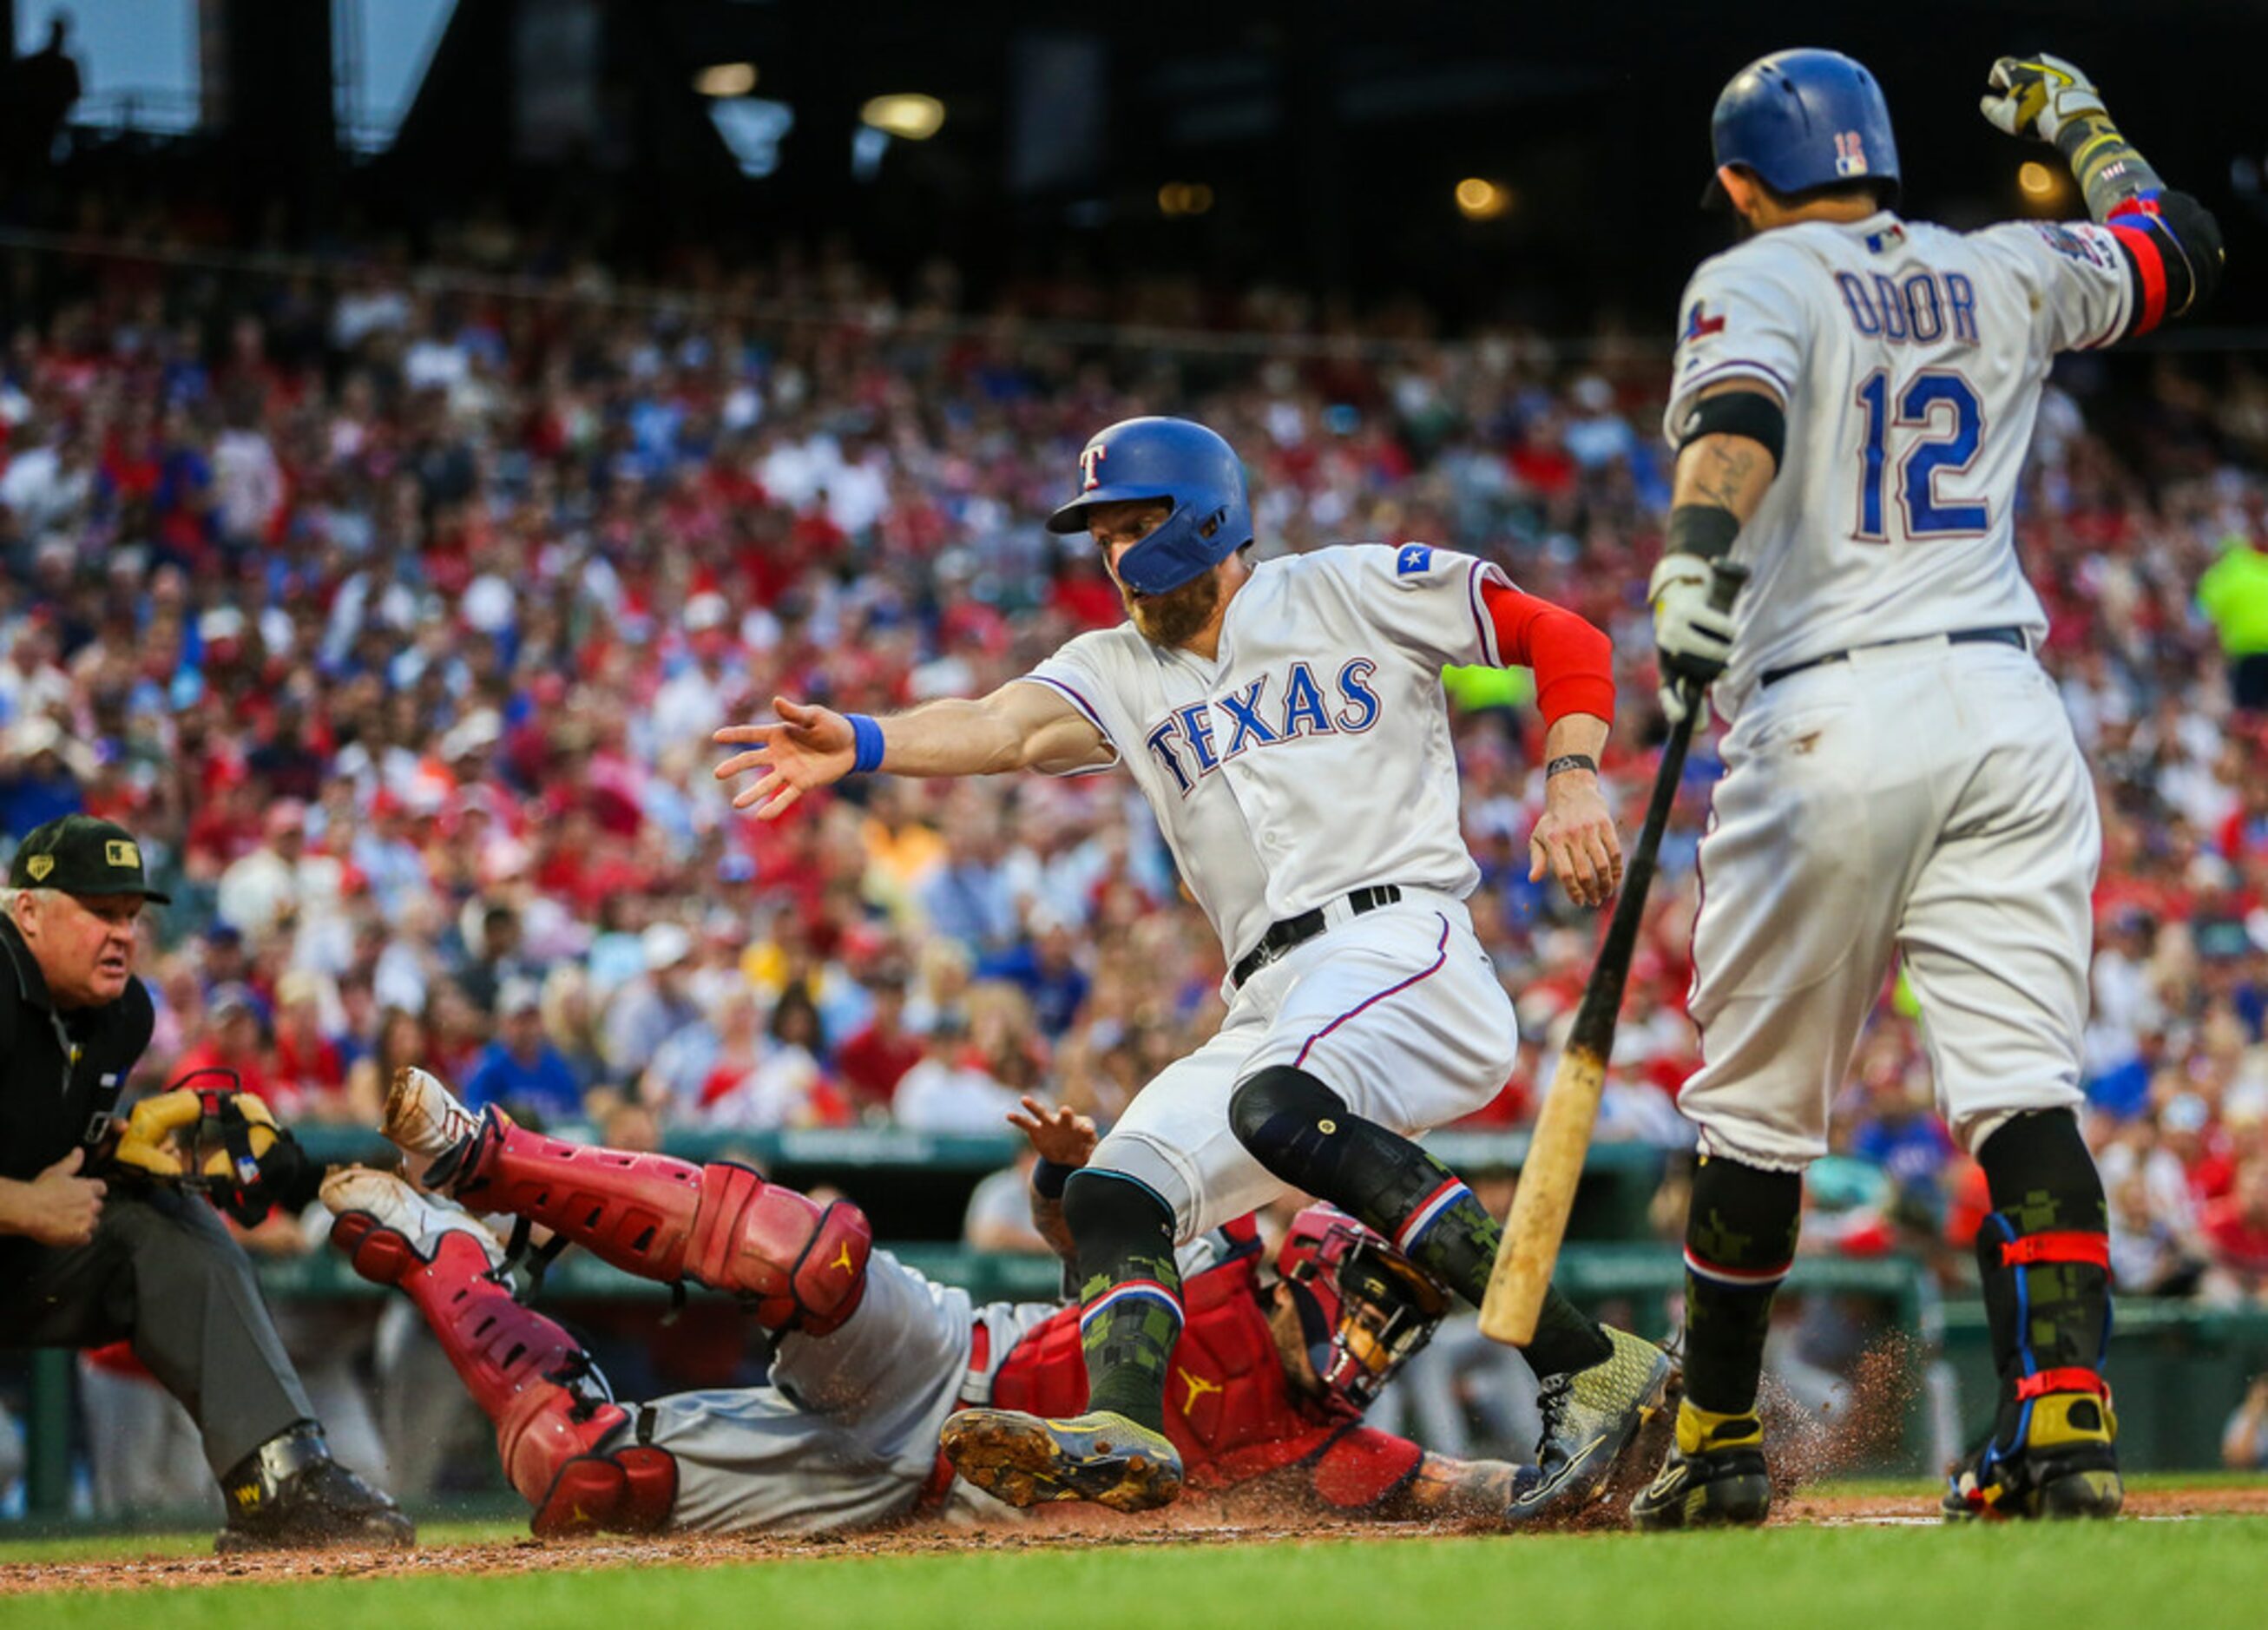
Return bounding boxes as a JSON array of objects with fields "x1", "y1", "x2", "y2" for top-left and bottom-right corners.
[{"x1": 1633, "y1": 49, "x2": 2220, "y2": 1528}]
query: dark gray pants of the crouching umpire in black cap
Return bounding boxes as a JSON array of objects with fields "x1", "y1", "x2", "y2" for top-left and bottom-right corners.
[{"x1": 0, "y1": 1190, "x2": 315, "y2": 1476}]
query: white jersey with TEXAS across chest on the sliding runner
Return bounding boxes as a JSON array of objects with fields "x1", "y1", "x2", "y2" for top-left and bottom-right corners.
[{"x1": 1025, "y1": 544, "x2": 1503, "y2": 963}]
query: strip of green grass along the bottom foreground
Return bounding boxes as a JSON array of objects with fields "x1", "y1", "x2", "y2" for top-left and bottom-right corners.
[{"x1": 0, "y1": 1519, "x2": 2268, "y2": 1630}]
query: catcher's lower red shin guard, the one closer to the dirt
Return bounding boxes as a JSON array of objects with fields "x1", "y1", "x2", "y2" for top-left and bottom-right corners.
[{"x1": 331, "y1": 1211, "x2": 678, "y2": 1535}]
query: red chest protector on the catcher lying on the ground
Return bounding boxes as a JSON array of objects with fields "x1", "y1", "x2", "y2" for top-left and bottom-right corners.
[{"x1": 991, "y1": 1219, "x2": 1422, "y2": 1505}]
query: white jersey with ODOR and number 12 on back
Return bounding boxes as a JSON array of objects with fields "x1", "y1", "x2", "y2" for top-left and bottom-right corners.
[{"x1": 1662, "y1": 211, "x2": 2132, "y2": 719}]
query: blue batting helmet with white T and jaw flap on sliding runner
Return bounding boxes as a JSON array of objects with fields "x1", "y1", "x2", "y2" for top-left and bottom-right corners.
[{"x1": 1048, "y1": 417, "x2": 1252, "y2": 594}]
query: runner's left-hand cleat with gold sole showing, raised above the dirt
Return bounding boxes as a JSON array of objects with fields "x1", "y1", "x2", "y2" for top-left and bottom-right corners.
[{"x1": 937, "y1": 1410, "x2": 1181, "y2": 1512}]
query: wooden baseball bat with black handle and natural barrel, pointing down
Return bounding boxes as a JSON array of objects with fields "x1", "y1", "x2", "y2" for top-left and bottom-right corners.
[{"x1": 1481, "y1": 560, "x2": 1749, "y2": 1347}]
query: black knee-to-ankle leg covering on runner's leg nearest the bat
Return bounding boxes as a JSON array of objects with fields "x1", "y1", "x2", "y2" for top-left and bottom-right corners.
[{"x1": 1229, "y1": 1063, "x2": 1614, "y2": 1376}]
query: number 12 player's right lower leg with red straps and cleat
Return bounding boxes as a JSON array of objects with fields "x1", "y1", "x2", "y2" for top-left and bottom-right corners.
[{"x1": 1946, "y1": 1111, "x2": 2123, "y2": 1516}]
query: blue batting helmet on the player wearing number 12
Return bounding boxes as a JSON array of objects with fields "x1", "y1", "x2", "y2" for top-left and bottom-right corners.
[{"x1": 1701, "y1": 49, "x2": 1898, "y2": 204}]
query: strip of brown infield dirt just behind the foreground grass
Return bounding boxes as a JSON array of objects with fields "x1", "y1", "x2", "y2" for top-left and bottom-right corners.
[{"x1": 0, "y1": 1485, "x2": 2268, "y2": 1596}]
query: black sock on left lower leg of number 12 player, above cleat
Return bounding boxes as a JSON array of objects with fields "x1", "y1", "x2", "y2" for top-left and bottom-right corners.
[{"x1": 1685, "y1": 1156, "x2": 1803, "y2": 1415}]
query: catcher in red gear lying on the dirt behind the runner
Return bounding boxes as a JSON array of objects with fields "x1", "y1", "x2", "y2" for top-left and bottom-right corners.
[{"x1": 322, "y1": 1070, "x2": 1658, "y2": 1535}]
